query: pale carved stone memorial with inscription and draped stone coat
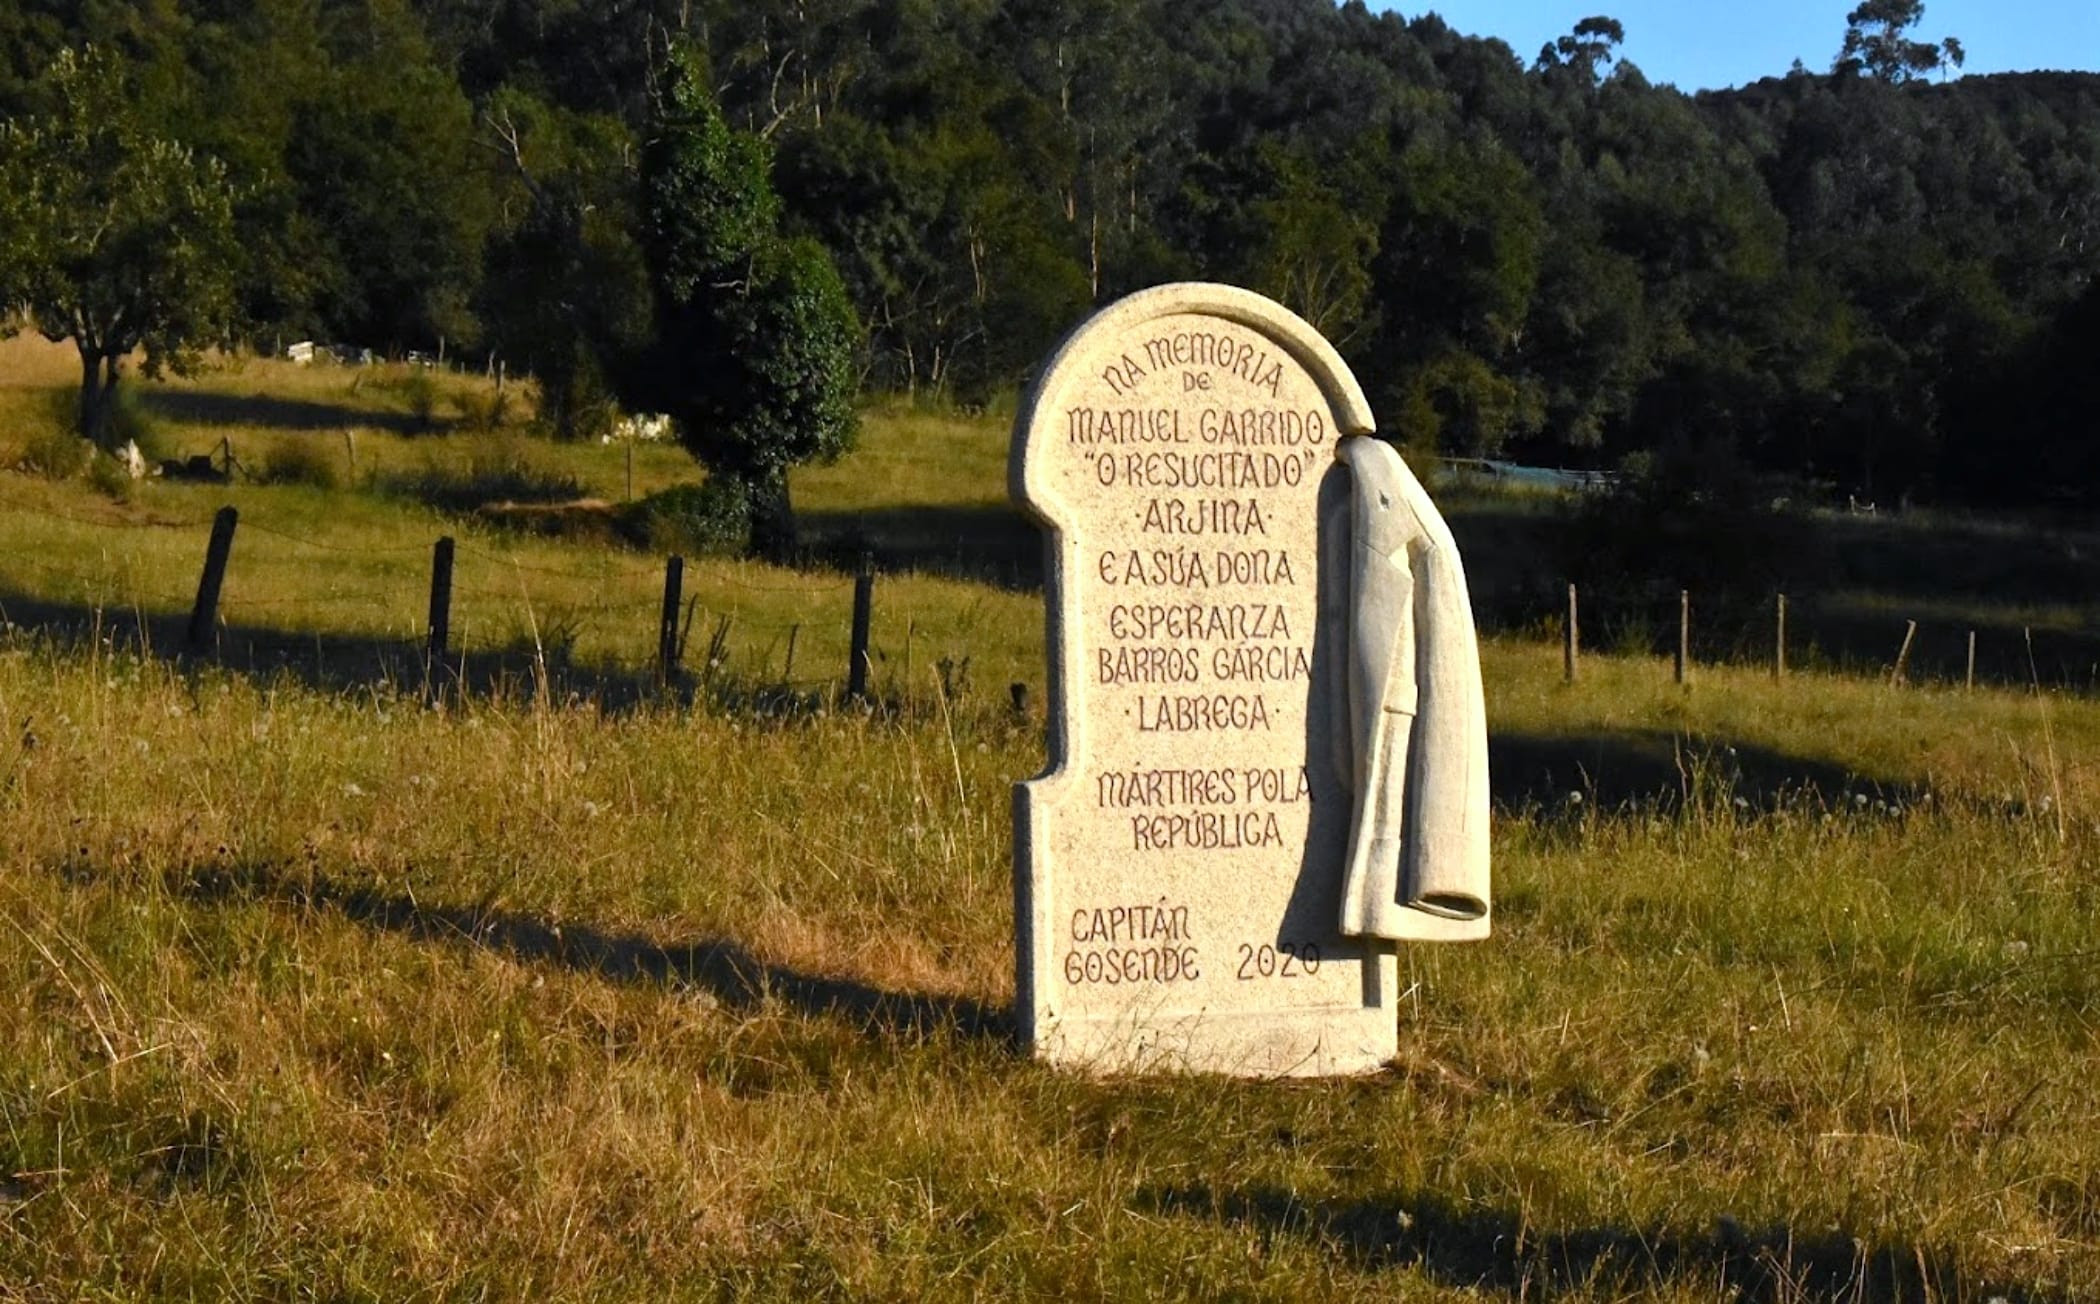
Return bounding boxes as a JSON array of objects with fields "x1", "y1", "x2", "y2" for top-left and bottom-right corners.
[{"x1": 1012, "y1": 283, "x2": 1489, "y2": 1077}]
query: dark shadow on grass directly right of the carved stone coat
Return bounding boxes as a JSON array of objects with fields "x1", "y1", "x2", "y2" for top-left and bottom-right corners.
[{"x1": 1487, "y1": 729, "x2": 1919, "y2": 811}]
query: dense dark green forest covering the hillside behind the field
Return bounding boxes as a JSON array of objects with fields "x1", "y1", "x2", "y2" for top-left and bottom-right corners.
[{"x1": 0, "y1": 0, "x2": 2100, "y2": 508}]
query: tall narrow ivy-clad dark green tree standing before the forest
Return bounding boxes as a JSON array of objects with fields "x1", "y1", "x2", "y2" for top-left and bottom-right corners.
[{"x1": 624, "y1": 50, "x2": 861, "y2": 556}]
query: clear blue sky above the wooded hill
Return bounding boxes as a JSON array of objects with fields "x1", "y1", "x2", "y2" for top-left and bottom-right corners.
[{"x1": 1373, "y1": 0, "x2": 2100, "y2": 90}]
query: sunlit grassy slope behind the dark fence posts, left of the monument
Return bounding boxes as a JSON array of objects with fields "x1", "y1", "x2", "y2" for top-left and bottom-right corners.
[{"x1": 0, "y1": 329, "x2": 1042, "y2": 701}]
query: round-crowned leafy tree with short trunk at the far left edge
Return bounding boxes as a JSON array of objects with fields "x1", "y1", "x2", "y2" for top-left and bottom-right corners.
[{"x1": 0, "y1": 48, "x2": 239, "y2": 447}]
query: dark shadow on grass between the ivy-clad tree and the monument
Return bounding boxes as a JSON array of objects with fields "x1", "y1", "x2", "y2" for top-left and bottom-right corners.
[{"x1": 796, "y1": 504, "x2": 1044, "y2": 592}]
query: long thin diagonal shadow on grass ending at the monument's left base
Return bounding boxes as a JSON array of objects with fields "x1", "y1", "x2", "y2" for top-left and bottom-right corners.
[{"x1": 187, "y1": 865, "x2": 1014, "y2": 1046}]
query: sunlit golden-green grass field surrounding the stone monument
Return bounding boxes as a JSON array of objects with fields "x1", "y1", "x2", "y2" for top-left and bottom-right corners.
[{"x1": 0, "y1": 346, "x2": 2100, "y2": 1304}]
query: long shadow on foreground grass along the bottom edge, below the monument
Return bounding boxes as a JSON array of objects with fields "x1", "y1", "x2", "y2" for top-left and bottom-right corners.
[{"x1": 1136, "y1": 1186, "x2": 2050, "y2": 1304}]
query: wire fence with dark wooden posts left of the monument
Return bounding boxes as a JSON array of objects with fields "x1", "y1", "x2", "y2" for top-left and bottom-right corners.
[{"x1": 0, "y1": 504, "x2": 909, "y2": 695}]
